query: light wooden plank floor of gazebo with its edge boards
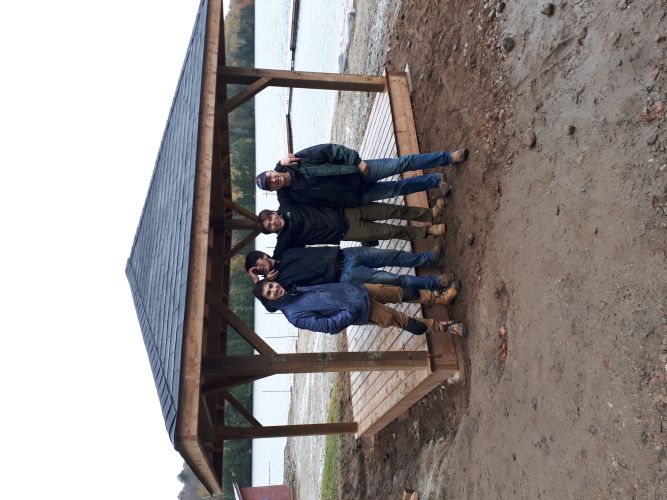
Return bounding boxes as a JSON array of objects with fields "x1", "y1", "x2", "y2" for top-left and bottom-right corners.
[{"x1": 347, "y1": 73, "x2": 463, "y2": 437}]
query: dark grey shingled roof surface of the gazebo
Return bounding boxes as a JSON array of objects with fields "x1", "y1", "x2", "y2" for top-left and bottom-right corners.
[{"x1": 125, "y1": 0, "x2": 208, "y2": 444}]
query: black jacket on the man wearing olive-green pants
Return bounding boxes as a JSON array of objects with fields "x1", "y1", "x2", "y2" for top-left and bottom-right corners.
[{"x1": 273, "y1": 205, "x2": 348, "y2": 259}]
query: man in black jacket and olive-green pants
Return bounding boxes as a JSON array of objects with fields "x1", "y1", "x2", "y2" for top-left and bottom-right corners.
[{"x1": 257, "y1": 203, "x2": 445, "y2": 259}]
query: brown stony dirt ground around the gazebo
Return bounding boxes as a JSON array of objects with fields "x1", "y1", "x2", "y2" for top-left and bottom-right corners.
[{"x1": 284, "y1": 0, "x2": 667, "y2": 499}]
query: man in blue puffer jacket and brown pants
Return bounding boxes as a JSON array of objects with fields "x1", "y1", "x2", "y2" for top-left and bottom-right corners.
[{"x1": 253, "y1": 280, "x2": 468, "y2": 337}]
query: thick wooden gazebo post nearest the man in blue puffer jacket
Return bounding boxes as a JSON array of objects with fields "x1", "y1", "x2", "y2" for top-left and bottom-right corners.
[{"x1": 202, "y1": 351, "x2": 429, "y2": 377}]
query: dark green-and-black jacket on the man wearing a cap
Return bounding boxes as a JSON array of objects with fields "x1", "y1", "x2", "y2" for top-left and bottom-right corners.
[{"x1": 275, "y1": 144, "x2": 364, "y2": 207}]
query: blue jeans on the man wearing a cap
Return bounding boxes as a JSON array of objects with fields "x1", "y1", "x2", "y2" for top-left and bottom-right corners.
[{"x1": 361, "y1": 151, "x2": 452, "y2": 205}]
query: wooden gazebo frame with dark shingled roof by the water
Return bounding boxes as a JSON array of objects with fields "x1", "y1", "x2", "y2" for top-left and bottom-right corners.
[{"x1": 126, "y1": 0, "x2": 460, "y2": 493}]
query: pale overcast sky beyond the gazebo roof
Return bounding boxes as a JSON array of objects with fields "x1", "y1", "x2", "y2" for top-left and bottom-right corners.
[{"x1": 0, "y1": 0, "x2": 228, "y2": 499}]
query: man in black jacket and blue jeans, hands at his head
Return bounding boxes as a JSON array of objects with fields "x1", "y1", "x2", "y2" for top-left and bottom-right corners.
[{"x1": 245, "y1": 240, "x2": 461, "y2": 298}]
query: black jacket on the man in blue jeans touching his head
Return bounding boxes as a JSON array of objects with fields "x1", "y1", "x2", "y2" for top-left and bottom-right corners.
[{"x1": 275, "y1": 247, "x2": 342, "y2": 290}]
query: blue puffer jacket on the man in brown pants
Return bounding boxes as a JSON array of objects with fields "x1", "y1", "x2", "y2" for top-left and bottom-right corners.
[{"x1": 262, "y1": 283, "x2": 371, "y2": 333}]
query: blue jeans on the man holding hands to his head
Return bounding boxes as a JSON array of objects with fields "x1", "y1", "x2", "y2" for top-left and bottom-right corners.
[{"x1": 340, "y1": 247, "x2": 440, "y2": 290}]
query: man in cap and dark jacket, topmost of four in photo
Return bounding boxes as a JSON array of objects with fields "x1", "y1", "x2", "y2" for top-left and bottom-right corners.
[{"x1": 255, "y1": 144, "x2": 468, "y2": 207}]
